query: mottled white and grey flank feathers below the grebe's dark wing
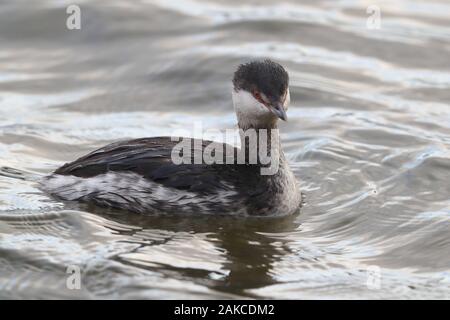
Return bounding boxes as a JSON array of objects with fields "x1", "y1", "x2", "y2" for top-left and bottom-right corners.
[{"x1": 41, "y1": 172, "x2": 245, "y2": 214}]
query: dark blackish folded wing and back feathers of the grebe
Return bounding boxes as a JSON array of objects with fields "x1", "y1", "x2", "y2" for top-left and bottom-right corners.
[{"x1": 55, "y1": 137, "x2": 264, "y2": 194}]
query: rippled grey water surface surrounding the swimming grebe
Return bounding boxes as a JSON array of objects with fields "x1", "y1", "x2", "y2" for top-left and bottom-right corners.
[{"x1": 0, "y1": 0, "x2": 450, "y2": 299}]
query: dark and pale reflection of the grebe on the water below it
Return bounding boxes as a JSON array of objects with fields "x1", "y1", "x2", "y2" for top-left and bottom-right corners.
[{"x1": 90, "y1": 207, "x2": 300, "y2": 294}]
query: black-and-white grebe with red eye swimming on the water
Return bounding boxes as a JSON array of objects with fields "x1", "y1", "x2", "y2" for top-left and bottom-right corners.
[{"x1": 41, "y1": 60, "x2": 301, "y2": 216}]
